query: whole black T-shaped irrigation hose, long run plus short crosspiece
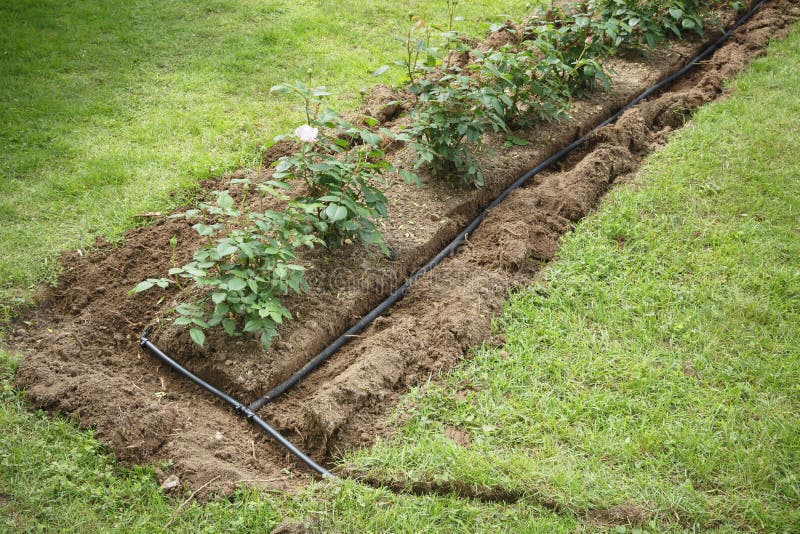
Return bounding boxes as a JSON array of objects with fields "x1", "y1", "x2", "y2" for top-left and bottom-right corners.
[{"x1": 139, "y1": 0, "x2": 767, "y2": 478}]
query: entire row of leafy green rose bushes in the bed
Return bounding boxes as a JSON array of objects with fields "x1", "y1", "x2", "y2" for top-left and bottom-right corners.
[{"x1": 132, "y1": 0, "x2": 739, "y2": 347}]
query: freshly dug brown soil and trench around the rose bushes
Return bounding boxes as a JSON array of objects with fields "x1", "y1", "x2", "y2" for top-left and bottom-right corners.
[{"x1": 7, "y1": 0, "x2": 800, "y2": 504}]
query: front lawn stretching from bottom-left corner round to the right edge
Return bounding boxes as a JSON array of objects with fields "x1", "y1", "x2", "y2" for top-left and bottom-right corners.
[{"x1": 0, "y1": 7, "x2": 800, "y2": 532}]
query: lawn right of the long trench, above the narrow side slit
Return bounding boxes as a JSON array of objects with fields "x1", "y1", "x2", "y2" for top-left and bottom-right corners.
[{"x1": 348, "y1": 24, "x2": 800, "y2": 532}]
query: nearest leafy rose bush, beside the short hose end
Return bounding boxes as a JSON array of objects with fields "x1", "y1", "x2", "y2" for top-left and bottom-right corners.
[{"x1": 133, "y1": 186, "x2": 322, "y2": 347}]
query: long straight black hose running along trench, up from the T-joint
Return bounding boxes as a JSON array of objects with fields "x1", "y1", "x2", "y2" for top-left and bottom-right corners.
[{"x1": 250, "y1": 0, "x2": 766, "y2": 411}]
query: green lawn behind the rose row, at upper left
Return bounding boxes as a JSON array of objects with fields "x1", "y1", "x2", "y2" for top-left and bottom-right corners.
[{"x1": 0, "y1": 0, "x2": 524, "y2": 315}]
